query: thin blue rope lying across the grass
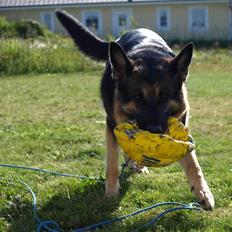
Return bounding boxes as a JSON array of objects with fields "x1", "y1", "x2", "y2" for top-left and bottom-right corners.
[{"x1": 0, "y1": 164, "x2": 202, "y2": 232}]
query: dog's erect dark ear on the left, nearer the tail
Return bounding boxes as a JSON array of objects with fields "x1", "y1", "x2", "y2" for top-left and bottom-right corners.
[{"x1": 109, "y1": 42, "x2": 132, "y2": 80}]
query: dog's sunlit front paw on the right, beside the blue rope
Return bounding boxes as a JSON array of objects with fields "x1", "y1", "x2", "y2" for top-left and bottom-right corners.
[{"x1": 192, "y1": 182, "x2": 215, "y2": 211}]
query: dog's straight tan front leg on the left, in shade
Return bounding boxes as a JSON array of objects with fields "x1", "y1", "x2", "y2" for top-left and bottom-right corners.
[{"x1": 105, "y1": 126, "x2": 120, "y2": 197}]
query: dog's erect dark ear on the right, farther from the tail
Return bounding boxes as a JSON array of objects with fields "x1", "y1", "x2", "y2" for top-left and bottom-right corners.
[{"x1": 171, "y1": 43, "x2": 193, "y2": 84}]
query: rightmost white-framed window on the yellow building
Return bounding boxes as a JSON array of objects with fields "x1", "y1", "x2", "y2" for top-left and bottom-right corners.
[{"x1": 189, "y1": 7, "x2": 208, "y2": 31}]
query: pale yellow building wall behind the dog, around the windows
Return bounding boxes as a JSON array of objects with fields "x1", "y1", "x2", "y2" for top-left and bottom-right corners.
[{"x1": 0, "y1": 3, "x2": 230, "y2": 40}]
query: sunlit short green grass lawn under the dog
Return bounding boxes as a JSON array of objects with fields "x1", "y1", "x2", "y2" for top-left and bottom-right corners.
[{"x1": 0, "y1": 50, "x2": 232, "y2": 232}]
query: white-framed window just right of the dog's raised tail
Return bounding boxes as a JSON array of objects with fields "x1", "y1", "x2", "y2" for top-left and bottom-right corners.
[{"x1": 82, "y1": 11, "x2": 102, "y2": 34}]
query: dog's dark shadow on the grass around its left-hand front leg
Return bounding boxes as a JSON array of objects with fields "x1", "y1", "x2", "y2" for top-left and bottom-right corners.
[{"x1": 40, "y1": 173, "x2": 133, "y2": 231}]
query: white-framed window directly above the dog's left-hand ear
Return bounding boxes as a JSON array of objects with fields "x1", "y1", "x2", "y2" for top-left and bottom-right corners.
[{"x1": 112, "y1": 9, "x2": 132, "y2": 36}]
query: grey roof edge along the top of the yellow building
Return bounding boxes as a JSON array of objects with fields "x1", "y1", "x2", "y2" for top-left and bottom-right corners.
[{"x1": 0, "y1": 0, "x2": 228, "y2": 8}]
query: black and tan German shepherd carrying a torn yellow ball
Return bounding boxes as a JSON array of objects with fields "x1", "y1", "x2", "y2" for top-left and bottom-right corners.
[{"x1": 56, "y1": 10, "x2": 214, "y2": 210}]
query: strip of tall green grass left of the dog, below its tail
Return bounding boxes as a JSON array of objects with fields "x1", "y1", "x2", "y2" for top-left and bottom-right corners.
[{"x1": 0, "y1": 36, "x2": 100, "y2": 75}]
